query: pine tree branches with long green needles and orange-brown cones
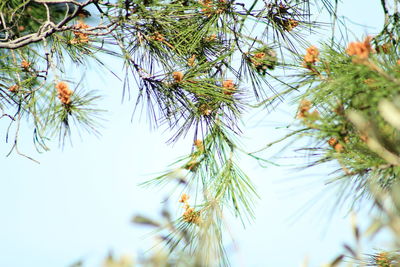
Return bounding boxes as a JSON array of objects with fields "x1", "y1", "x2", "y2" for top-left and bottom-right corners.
[{"x1": 0, "y1": 0, "x2": 400, "y2": 266}]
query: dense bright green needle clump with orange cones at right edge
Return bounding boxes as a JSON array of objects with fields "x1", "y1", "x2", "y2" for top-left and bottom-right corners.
[{"x1": 280, "y1": 34, "x2": 400, "y2": 205}]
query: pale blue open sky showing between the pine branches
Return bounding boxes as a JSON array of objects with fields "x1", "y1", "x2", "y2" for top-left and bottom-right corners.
[{"x1": 0, "y1": 0, "x2": 390, "y2": 267}]
